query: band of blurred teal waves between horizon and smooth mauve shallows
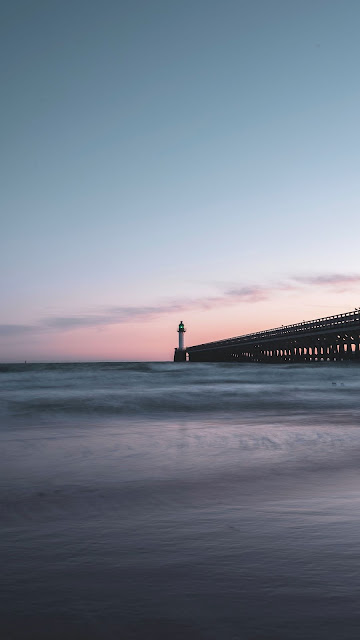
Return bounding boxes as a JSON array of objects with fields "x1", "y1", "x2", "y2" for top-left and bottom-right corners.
[{"x1": 0, "y1": 362, "x2": 360, "y2": 420}]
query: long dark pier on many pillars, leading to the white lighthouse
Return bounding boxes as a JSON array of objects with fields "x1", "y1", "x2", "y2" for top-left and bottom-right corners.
[{"x1": 184, "y1": 309, "x2": 360, "y2": 363}]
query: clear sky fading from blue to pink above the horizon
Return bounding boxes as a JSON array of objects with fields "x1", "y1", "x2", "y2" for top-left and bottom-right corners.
[{"x1": 0, "y1": 0, "x2": 360, "y2": 362}]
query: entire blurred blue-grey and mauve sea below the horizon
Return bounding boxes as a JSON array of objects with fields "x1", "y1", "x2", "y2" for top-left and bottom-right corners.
[{"x1": 0, "y1": 363, "x2": 360, "y2": 640}]
